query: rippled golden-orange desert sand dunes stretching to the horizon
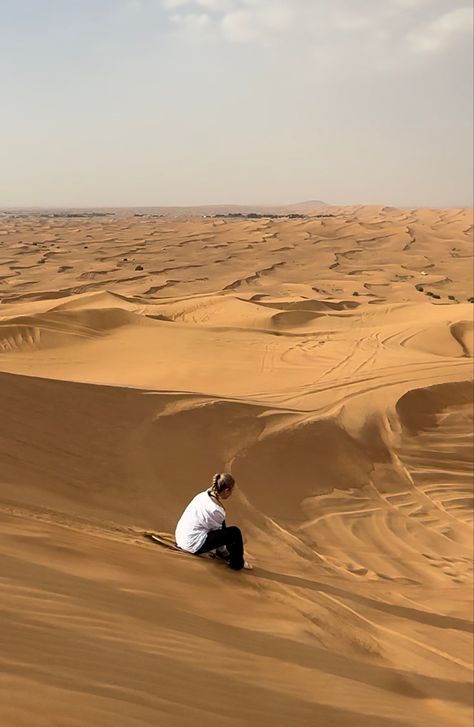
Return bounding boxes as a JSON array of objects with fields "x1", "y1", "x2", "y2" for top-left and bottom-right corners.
[{"x1": 0, "y1": 207, "x2": 473, "y2": 727}]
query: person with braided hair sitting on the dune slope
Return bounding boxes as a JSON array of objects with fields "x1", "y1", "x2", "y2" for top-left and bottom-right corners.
[{"x1": 175, "y1": 474, "x2": 252, "y2": 570}]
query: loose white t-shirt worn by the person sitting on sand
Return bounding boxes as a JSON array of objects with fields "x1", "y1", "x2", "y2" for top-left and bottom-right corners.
[{"x1": 175, "y1": 490, "x2": 225, "y2": 553}]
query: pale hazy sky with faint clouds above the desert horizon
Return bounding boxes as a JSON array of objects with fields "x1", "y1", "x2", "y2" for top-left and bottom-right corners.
[{"x1": 0, "y1": 0, "x2": 473, "y2": 207}]
